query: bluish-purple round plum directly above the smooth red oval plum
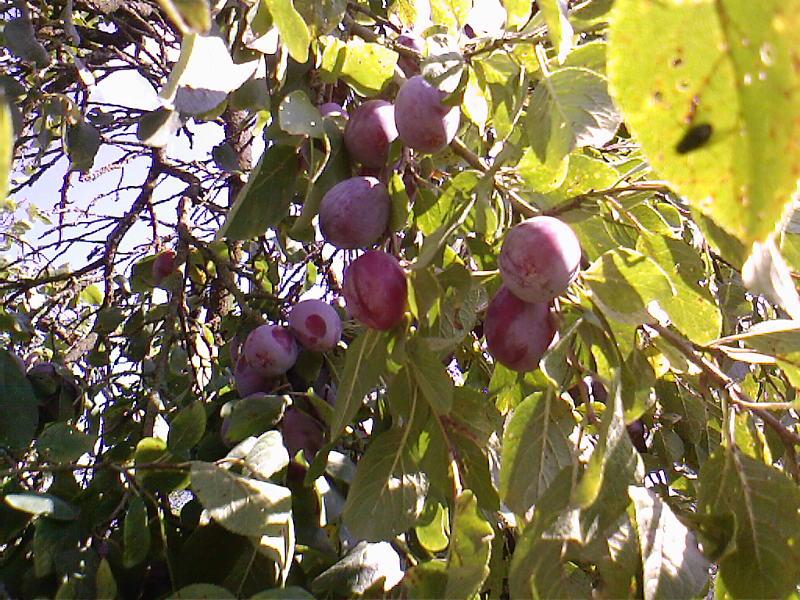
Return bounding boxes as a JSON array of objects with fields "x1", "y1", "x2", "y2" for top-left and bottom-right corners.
[{"x1": 319, "y1": 177, "x2": 391, "y2": 249}]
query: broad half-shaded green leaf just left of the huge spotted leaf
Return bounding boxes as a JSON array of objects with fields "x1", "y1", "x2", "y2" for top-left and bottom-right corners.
[{"x1": 526, "y1": 67, "x2": 620, "y2": 163}]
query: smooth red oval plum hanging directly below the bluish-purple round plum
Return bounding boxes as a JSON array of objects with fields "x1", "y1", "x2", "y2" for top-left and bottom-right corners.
[{"x1": 342, "y1": 250, "x2": 408, "y2": 331}]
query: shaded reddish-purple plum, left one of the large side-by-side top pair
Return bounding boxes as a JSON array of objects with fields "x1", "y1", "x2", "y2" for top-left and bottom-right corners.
[{"x1": 344, "y1": 100, "x2": 397, "y2": 169}]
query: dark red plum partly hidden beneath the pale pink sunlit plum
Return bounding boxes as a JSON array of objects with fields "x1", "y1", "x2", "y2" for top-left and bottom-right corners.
[{"x1": 483, "y1": 287, "x2": 556, "y2": 372}]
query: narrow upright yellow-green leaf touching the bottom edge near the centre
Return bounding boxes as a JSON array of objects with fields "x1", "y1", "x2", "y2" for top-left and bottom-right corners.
[{"x1": 444, "y1": 490, "x2": 494, "y2": 599}]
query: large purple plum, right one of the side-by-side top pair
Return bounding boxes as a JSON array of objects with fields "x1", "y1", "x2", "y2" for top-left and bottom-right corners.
[{"x1": 394, "y1": 75, "x2": 461, "y2": 154}]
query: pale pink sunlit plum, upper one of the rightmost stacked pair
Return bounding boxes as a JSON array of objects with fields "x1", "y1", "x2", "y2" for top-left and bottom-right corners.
[{"x1": 500, "y1": 216, "x2": 581, "y2": 302}]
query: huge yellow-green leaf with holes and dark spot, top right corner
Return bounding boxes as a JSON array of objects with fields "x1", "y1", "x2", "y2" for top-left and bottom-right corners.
[{"x1": 608, "y1": 0, "x2": 800, "y2": 247}]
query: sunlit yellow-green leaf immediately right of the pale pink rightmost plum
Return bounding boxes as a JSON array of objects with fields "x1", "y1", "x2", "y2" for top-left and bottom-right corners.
[{"x1": 583, "y1": 248, "x2": 675, "y2": 325}]
